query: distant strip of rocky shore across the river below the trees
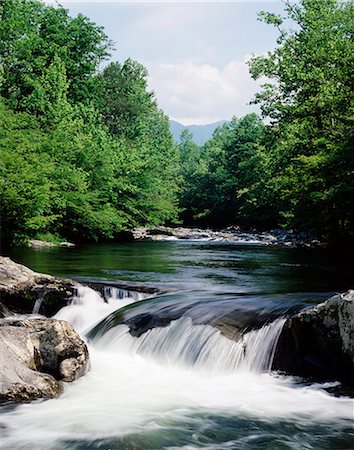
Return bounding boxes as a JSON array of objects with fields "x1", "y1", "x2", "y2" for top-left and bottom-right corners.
[{"x1": 126, "y1": 227, "x2": 326, "y2": 247}]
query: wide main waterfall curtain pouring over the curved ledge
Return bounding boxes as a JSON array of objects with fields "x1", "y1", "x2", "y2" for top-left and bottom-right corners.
[{"x1": 95, "y1": 316, "x2": 285, "y2": 372}]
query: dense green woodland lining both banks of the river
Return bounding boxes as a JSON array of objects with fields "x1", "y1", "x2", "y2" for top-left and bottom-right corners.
[{"x1": 0, "y1": 0, "x2": 354, "y2": 243}]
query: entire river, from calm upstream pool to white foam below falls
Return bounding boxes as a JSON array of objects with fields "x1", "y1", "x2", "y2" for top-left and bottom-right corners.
[{"x1": 0, "y1": 241, "x2": 354, "y2": 450}]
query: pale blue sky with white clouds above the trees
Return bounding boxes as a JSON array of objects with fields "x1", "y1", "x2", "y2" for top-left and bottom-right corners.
[{"x1": 59, "y1": 0, "x2": 283, "y2": 125}]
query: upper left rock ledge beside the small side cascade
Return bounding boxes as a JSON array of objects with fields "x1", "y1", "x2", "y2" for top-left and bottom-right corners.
[{"x1": 0, "y1": 257, "x2": 77, "y2": 316}]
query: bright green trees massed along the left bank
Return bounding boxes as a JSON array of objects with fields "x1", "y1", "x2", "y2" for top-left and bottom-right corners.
[{"x1": 0, "y1": 0, "x2": 179, "y2": 243}]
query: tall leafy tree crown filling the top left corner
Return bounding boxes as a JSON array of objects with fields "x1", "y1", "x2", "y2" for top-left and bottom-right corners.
[{"x1": 0, "y1": 0, "x2": 111, "y2": 110}]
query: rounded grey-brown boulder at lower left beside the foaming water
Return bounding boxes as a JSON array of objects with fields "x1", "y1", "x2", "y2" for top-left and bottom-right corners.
[{"x1": 0, "y1": 319, "x2": 89, "y2": 402}]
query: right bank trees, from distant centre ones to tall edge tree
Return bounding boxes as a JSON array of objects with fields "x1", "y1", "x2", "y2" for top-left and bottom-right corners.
[{"x1": 180, "y1": 0, "x2": 354, "y2": 238}]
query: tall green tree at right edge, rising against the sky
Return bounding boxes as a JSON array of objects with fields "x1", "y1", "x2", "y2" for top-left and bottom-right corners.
[{"x1": 250, "y1": 0, "x2": 354, "y2": 236}]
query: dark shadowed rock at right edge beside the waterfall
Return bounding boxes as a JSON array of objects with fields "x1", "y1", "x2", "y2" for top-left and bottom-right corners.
[{"x1": 273, "y1": 290, "x2": 354, "y2": 387}]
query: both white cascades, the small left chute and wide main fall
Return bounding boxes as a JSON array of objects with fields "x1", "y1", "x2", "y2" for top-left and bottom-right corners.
[{"x1": 55, "y1": 286, "x2": 285, "y2": 373}]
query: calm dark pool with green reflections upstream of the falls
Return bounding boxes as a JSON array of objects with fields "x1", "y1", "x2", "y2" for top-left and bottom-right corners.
[{"x1": 8, "y1": 241, "x2": 354, "y2": 294}]
